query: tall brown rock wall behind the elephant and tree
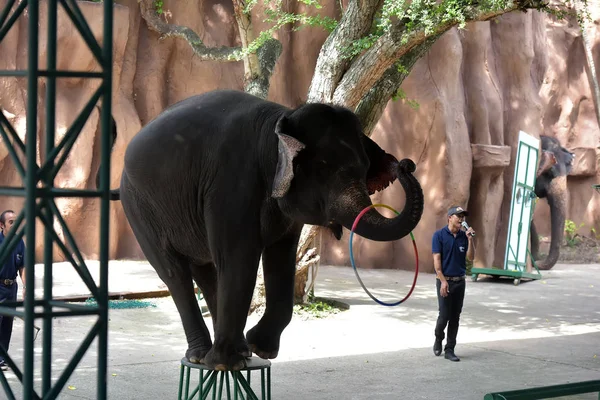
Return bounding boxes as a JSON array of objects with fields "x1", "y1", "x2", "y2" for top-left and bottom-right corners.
[{"x1": 0, "y1": 0, "x2": 600, "y2": 271}]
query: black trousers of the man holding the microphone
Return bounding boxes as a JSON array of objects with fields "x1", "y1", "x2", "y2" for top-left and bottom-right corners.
[{"x1": 435, "y1": 279, "x2": 466, "y2": 351}]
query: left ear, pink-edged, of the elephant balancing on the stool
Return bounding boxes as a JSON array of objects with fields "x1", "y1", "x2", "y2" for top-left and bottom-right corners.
[{"x1": 271, "y1": 115, "x2": 306, "y2": 198}]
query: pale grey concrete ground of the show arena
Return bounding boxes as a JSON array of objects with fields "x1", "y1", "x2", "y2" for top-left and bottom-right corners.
[{"x1": 0, "y1": 262, "x2": 600, "y2": 400}]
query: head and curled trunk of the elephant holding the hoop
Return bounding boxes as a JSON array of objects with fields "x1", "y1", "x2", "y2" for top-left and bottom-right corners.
[{"x1": 272, "y1": 104, "x2": 423, "y2": 241}]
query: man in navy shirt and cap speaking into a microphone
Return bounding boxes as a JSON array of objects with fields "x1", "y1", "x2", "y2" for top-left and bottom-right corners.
[{"x1": 431, "y1": 206, "x2": 475, "y2": 361}]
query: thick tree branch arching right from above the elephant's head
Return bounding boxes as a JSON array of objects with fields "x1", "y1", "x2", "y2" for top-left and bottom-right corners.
[{"x1": 333, "y1": 0, "x2": 546, "y2": 109}]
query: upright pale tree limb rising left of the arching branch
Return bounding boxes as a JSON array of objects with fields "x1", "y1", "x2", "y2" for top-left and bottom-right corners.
[{"x1": 308, "y1": 0, "x2": 383, "y2": 102}]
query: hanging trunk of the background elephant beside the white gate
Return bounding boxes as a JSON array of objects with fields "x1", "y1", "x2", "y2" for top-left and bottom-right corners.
[{"x1": 538, "y1": 176, "x2": 567, "y2": 270}]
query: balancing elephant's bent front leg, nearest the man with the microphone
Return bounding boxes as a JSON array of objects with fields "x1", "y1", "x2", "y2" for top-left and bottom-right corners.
[{"x1": 246, "y1": 233, "x2": 300, "y2": 359}]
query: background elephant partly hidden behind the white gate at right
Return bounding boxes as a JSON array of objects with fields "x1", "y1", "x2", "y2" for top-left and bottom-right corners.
[{"x1": 530, "y1": 135, "x2": 575, "y2": 270}]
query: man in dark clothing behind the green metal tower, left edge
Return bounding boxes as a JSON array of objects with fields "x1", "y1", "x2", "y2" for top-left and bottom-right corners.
[{"x1": 0, "y1": 210, "x2": 26, "y2": 371}]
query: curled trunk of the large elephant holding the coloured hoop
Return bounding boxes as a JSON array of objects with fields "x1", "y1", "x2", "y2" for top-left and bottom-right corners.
[{"x1": 333, "y1": 159, "x2": 423, "y2": 242}]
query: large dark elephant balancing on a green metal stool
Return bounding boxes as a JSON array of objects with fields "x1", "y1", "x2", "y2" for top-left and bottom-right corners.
[{"x1": 111, "y1": 90, "x2": 423, "y2": 370}]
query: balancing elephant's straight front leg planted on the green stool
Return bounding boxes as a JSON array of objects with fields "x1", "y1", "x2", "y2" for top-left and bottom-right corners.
[{"x1": 204, "y1": 244, "x2": 260, "y2": 371}]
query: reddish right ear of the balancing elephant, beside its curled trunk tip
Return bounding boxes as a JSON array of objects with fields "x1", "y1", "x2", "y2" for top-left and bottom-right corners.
[{"x1": 363, "y1": 135, "x2": 398, "y2": 195}]
